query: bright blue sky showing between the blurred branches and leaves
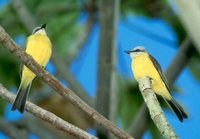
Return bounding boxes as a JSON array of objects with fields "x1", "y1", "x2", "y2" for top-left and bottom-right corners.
[{"x1": 0, "y1": 1, "x2": 200, "y2": 139}]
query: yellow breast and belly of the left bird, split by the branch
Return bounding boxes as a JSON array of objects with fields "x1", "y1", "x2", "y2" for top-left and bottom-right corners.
[{"x1": 21, "y1": 34, "x2": 51, "y2": 87}]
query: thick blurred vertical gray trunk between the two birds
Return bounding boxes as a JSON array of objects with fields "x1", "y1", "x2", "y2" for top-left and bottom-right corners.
[{"x1": 96, "y1": 0, "x2": 119, "y2": 139}]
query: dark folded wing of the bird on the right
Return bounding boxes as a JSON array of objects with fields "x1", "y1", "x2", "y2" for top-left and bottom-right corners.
[{"x1": 149, "y1": 54, "x2": 170, "y2": 92}]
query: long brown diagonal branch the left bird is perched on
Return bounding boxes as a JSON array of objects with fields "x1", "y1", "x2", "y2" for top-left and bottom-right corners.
[{"x1": 0, "y1": 26, "x2": 132, "y2": 139}]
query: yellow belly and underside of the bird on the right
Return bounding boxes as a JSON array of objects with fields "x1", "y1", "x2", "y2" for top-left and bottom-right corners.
[{"x1": 132, "y1": 54, "x2": 171, "y2": 99}]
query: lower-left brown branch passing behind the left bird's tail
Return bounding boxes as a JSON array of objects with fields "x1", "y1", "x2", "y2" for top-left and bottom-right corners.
[{"x1": 0, "y1": 84, "x2": 97, "y2": 139}]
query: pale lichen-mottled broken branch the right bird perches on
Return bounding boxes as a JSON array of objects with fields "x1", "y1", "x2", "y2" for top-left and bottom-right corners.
[{"x1": 139, "y1": 77, "x2": 178, "y2": 139}]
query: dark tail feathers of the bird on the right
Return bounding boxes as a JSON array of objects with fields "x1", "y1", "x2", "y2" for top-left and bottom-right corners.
[{"x1": 164, "y1": 98, "x2": 188, "y2": 122}]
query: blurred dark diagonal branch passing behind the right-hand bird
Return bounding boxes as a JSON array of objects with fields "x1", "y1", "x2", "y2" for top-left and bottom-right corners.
[{"x1": 129, "y1": 37, "x2": 195, "y2": 138}]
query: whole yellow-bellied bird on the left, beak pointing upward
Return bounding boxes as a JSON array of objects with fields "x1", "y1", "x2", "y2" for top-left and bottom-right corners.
[{"x1": 12, "y1": 24, "x2": 51, "y2": 113}]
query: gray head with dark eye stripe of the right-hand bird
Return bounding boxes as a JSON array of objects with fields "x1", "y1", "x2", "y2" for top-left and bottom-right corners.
[{"x1": 125, "y1": 46, "x2": 147, "y2": 59}]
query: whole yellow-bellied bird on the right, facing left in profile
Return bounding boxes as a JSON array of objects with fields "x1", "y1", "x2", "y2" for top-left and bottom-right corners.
[{"x1": 125, "y1": 46, "x2": 188, "y2": 122}]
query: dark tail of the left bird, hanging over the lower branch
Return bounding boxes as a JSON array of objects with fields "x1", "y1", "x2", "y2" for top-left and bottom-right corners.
[{"x1": 11, "y1": 83, "x2": 31, "y2": 113}]
